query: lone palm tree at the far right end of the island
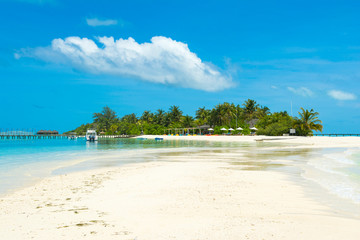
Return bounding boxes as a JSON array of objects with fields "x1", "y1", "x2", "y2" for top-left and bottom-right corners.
[{"x1": 294, "y1": 108, "x2": 323, "y2": 135}]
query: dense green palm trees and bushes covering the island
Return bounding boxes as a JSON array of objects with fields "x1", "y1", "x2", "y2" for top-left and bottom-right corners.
[{"x1": 69, "y1": 99, "x2": 323, "y2": 136}]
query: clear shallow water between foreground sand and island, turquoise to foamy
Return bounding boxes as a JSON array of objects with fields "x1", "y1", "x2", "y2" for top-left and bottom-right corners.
[{"x1": 0, "y1": 139, "x2": 360, "y2": 211}]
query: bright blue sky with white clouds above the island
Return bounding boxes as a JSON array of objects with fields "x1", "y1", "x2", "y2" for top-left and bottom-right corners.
[{"x1": 0, "y1": 0, "x2": 360, "y2": 133}]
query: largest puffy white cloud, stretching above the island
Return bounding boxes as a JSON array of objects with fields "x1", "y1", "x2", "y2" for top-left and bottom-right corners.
[{"x1": 23, "y1": 36, "x2": 234, "y2": 91}]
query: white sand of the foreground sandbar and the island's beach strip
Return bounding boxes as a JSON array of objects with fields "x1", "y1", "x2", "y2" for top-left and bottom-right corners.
[{"x1": 0, "y1": 136, "x2": 360, "y2": 240}]
